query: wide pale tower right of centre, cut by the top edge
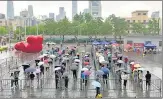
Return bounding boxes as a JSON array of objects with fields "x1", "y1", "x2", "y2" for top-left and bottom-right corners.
[{"x1": 89, "y1": 1, "x2": 102, "y2": 18}]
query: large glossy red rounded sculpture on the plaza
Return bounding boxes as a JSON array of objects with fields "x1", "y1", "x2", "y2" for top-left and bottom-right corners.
[{"x1": 15, "y1": 35, "x2": 43, "y2": 53}]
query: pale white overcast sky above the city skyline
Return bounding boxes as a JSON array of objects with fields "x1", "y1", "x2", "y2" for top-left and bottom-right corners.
[{"x1": 0, "y1": 1, "x2": 162, "y2": 19}]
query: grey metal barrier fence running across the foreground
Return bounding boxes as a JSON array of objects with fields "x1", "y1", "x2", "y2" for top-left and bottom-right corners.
[{"x1": 0, "y1": 78, "x2": 162, "y2": 97}]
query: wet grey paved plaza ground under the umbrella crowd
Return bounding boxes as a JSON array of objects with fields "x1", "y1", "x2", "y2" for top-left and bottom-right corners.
[{"x1": 0, "y1": 45, "x2": 162, "y2": 98}]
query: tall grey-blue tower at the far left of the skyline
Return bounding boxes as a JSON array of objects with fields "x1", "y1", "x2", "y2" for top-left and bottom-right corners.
[{"x1": 7, "y1": 0, "x2": 14, "y2": 19}]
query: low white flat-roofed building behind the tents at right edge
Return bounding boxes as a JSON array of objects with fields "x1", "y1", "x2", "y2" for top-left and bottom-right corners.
[{"x1": 124, "y1": 35, "x2": 162, "y2": 50}]
